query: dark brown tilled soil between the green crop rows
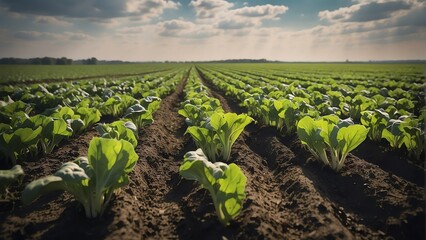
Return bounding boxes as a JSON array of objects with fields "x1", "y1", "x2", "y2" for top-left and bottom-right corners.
[{"x1": 0, "y1": 70, "x2": 425, "y2": 239}]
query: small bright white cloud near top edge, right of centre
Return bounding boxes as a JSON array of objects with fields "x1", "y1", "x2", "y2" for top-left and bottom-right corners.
[{"x1": 233, "y1": 4, "x2": 288, "y2": 19}]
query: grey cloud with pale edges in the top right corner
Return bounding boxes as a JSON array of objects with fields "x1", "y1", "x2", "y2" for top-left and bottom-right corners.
[{"x1": 318, "y1": 0, "x2": 416, "y2": 22}]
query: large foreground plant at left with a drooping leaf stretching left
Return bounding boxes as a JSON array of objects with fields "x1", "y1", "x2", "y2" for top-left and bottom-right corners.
[{"x1": 22, "y1": 138, "x2": 138, "y2": 218}]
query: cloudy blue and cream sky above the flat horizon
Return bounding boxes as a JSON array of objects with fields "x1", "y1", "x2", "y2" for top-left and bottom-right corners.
[{"x1": 0, "y1": 0, "x2": 426, "y2": 61}]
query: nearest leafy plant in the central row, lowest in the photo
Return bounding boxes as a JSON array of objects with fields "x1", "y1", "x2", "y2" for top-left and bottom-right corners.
[{"x1": 179, "y1": 148, "x2": 247, "y2": 226}]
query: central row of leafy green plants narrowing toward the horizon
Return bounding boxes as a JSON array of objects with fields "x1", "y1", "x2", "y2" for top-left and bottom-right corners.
[{"x1": 179, "y1": 69, "x2": 252, "y2": 225}]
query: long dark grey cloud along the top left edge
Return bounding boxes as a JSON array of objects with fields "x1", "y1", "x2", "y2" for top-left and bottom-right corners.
[{"x1": 0, "y1": 0, "x2": 179, "y2": 18}]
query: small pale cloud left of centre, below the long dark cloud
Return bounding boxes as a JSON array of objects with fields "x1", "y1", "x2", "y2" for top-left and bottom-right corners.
[{"x1": 159, "y1": 19, "x2": 219, "y2": 39}]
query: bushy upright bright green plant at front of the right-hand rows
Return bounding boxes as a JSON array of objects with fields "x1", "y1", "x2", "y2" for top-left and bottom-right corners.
[{"x1": 297, "y1": 115, "x2": 368, "y2": 171}]
